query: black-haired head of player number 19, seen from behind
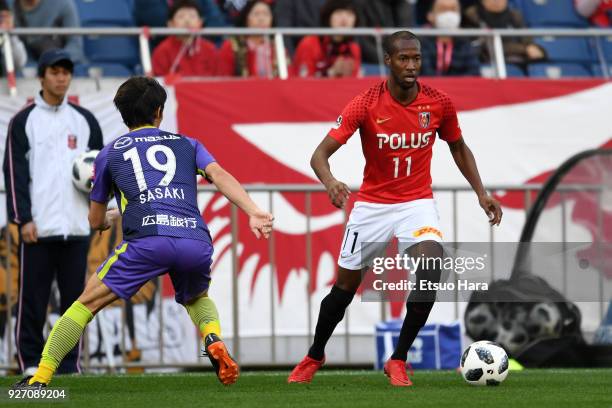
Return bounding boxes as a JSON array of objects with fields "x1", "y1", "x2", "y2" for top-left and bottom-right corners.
[{"x1": 113, "y1": 76, "x2": 167, "y2": 129}]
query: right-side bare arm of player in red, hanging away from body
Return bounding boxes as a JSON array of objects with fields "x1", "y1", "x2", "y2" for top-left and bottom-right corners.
[{"x1": 448, "y1": 137, "x2": 503, "y2": 225}]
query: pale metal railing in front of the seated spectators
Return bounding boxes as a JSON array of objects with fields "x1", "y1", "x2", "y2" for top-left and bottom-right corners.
[{"x1": 0, "y1": 27, "x2": 612, "y2": 95}]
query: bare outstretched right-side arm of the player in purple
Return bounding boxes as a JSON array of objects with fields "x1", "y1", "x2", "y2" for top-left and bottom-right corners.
[{"x1": 204, "y1": 162, "x2": 274, "y2": 238}]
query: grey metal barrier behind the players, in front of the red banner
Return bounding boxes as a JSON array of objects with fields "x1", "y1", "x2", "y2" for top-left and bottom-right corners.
[{"x1": 0, "y1": 184, "x2": 604, "y2": 372}]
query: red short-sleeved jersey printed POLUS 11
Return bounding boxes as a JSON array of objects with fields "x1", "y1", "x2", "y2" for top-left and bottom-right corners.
[{"x1": 328, "y1": 81, "x2": 461, "y2": 204}]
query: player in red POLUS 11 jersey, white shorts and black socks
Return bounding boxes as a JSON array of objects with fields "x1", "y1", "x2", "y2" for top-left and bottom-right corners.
[{"x1": 288, "y1": 31, "x2": 502, "y2": 386}]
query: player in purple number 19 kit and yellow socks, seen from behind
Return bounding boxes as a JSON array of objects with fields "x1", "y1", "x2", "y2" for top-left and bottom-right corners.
[{"x1": 16, "y1": 77, "x2": 273, "y2": 388}]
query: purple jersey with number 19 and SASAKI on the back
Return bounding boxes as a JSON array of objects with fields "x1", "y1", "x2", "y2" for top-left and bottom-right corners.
[{"x1": 90, "y1": 127, "x2": 215, "y2": 243}]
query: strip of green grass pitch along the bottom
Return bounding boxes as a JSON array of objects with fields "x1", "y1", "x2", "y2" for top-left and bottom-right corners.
[{"x1": 0, "y1": 369, "x2": 612, "y2": 408}]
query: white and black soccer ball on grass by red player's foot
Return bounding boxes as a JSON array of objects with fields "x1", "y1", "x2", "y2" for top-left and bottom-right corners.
[{"x1": 461, "y1": 341, "x2": 508, "y2": 385}]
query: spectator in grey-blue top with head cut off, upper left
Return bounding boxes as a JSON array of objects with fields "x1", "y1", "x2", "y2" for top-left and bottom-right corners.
[{"x1": 13, "y1": 0, "x2": 85, "y2": 63}]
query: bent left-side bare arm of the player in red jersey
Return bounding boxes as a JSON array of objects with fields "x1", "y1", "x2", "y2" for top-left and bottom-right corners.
[{"x1": 310, "y1": 136, "x2": 351, "y2": 208}]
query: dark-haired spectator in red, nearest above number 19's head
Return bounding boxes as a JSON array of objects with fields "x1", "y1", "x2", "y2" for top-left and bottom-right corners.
[{"x1": 153, "y1": 0, "x2": 218, "y2": 76}]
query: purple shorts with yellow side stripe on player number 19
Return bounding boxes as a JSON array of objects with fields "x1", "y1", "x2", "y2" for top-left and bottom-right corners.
[{"x1": 97, "y1": 235, "x2": 213, "y2": 304}]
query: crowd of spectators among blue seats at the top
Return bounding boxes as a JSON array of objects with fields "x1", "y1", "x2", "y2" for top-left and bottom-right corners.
[{"x1": 0, "y1": 0, "x2": 612, "y2": 78}]
